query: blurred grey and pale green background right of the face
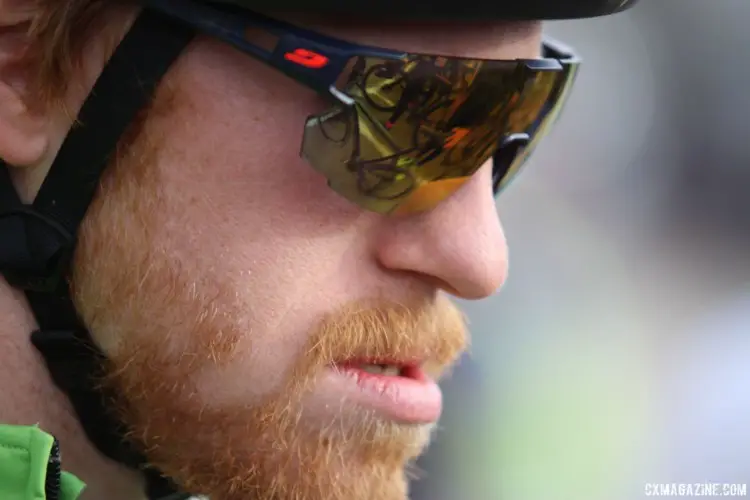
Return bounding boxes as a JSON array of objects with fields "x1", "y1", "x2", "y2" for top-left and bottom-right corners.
[{"x1": 412, "y1": 0, "x2": 750, "y2": 500}]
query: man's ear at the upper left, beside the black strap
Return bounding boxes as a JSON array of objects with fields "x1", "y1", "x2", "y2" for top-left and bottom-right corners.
[{"x1": 0, "y1": 5, "x2": 49, "y2": 167}]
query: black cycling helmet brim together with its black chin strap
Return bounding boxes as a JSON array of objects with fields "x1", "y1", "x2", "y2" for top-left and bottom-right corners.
[{"x1": 0, "y1": 0, "x2": 638, "y2": 498}]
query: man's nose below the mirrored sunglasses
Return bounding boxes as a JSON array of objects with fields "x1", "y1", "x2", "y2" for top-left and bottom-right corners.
[{"x1": 376, "y1": 163, "x2": 508, "y2": 299}]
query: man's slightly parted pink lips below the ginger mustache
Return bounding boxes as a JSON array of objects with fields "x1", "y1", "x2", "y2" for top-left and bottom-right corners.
[{"x1": 328, "y1": 360, "x2": 443, "y2": 424}]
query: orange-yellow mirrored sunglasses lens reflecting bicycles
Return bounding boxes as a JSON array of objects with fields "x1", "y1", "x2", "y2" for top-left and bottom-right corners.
[{"x1": 302, "y1": 55, "x2": 570, "y2": 213}]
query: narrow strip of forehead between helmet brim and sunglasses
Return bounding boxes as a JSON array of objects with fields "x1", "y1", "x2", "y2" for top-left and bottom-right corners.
[{"x1": 271, "y1": 14, "x2": 542, "y2": 59}]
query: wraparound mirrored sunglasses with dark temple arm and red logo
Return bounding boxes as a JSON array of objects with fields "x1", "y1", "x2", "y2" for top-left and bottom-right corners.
[{"x1": 143, "y1": 0, "x2": 580, "y2": 214}]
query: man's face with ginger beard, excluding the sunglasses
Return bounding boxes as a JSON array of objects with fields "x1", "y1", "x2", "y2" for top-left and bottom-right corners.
[{"x1": 66, "y1": 10, "x2": 541, "y2": 500}]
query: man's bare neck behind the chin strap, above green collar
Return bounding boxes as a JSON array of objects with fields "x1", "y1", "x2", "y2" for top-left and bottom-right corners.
[{"x1": 0, "y1": 278, "x2": 145, "y2": 500}]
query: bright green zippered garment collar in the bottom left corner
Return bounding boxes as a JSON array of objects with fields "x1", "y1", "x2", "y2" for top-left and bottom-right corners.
[{"x1": 0, "y1": 425, "x2": 85, "y2": 500}]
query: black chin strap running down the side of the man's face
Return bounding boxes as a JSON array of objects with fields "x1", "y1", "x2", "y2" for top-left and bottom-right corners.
[{"x1": 0, "y1": 10, "x2": 194, "y2": 500}]
